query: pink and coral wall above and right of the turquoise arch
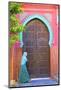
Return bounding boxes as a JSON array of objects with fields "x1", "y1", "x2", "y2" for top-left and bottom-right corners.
[{"x1": 17, "y1": 4, "x2": 59, "y2": 78}]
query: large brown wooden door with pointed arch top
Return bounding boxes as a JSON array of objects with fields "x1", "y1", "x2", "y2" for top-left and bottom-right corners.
[{"x1": 23, "y1": 18, "x2": 50, "y2": 78}]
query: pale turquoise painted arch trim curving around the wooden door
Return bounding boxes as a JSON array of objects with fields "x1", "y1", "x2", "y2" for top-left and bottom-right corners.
[{"x1": 19, "y1": 14, "x2": 53, "y2": 80}]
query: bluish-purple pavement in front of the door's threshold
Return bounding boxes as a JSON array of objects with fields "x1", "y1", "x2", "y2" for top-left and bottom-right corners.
[{"x1": 16, "y1": 78, "x2": 58, "y2": 87}]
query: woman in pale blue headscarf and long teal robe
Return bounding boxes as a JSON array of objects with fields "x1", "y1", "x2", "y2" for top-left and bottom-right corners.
[{"x1": 19, "y1": 52, "x2": 30, "y2": 83}]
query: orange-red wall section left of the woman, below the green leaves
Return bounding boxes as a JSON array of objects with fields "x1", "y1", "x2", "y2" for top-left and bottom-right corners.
[{"x1": 9, "y1": 45, "x2": 22, "y2": 81}]
